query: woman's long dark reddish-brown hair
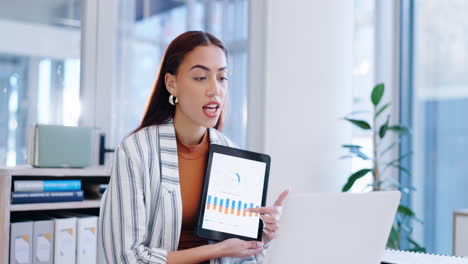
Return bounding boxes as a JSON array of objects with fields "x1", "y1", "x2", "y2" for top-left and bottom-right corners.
[{"x1": 132, "y1": 31, "x2": 228, "y2": 133}]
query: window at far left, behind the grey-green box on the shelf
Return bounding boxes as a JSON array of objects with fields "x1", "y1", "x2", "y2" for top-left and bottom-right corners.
[{"x1": 0, "y1": 0, "x2": 82, "y2": 166}]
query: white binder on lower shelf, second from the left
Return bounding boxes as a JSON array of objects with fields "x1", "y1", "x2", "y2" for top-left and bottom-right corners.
[{"x1": 32, "y1": 214, "x2": 54, "y2": 264}]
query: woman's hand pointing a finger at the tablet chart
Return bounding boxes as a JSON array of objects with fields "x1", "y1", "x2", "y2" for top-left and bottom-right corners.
[{"x1": 247, "y1": 189, "x2": 289, "y2": 243}]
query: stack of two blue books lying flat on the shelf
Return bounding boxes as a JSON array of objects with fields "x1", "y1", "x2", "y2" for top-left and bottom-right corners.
[{"x1": 11, "y1": 180, "x2": 84, "y2": 204}]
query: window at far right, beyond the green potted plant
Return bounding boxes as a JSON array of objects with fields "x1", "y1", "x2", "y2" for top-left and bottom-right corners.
[{"x1": 403, "y1": 0, "x2": 468, "y2": 254}]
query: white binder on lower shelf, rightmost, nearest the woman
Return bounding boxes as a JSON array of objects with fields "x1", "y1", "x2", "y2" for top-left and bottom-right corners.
[{"x1": 60, "y1": 213, "x2": 100, "y2": 264}]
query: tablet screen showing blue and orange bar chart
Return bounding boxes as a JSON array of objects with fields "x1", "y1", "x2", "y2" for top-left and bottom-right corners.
[{"x1": 202, "y1": 153, "x2": 266, "y2": 238}]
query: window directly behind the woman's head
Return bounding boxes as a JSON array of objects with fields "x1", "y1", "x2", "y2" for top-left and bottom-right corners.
[{"x1": 111, "y1": 0, "x2": 248, "y2": 147}]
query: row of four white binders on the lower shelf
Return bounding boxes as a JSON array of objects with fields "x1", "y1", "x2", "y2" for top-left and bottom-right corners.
[{"x1": 10, "y1": 213, "x2": 104, "y2": 264}]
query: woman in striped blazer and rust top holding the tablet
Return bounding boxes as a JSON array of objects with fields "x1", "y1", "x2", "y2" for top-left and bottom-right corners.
[{"x1": 99, "y1": 31, "x2": 287, "y2": 263}]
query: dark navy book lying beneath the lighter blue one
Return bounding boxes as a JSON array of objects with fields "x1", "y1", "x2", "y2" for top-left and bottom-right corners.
[{"x1": 11, "y1": 190, "x2": 84, "y2": 204}]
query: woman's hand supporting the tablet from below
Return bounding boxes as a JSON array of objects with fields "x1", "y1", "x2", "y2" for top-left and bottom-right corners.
[{"x1": 216, "y1": 238, "x2": 263, "y2": 259}]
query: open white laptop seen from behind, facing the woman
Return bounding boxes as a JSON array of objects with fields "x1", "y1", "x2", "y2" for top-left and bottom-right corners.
[{"x1": 265, "y1": 191, "x2": 400, "y2": 264}]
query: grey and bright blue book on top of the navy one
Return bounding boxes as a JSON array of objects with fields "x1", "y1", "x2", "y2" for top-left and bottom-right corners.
[{"x1": 13, "y1": 180, "x2": 81, "y2": 192}]
